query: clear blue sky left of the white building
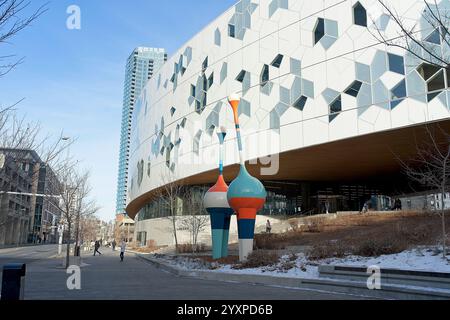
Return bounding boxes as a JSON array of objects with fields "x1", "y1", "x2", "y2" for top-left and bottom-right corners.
[{"x1": 0, "y1": 0, "x2": 236, "y2": 220}]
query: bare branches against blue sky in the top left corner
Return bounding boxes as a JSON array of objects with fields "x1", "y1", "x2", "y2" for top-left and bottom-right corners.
[{"x1": 0, "y1": 0, "x2": 47, "y2": 82}]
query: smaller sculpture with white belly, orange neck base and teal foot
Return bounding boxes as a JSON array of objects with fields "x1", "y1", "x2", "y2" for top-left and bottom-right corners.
[{"x1": 203, "y1": 127, "x2": 234, "y2": 259}]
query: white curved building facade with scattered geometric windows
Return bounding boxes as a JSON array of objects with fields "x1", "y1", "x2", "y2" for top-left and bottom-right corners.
[{"x1": 127, "y1": 0, "x2": 450, "y2": 246}]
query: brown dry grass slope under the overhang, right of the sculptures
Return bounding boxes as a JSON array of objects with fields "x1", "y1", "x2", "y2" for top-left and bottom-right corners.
[{"x1": 255, "y1": 211, "x2": 450, "y2": 260}]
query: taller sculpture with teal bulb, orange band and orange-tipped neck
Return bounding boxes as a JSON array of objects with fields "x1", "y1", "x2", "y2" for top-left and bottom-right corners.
[{"x1": 227, "y1": 94, "x2": 267, "y2": 261}]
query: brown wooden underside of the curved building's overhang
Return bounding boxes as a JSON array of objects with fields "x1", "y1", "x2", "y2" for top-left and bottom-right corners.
[{"x1": 127, "y1": 120, "x2": 450, "y2": 218}]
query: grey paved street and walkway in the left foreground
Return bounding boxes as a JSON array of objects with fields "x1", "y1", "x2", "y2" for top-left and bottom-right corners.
[{"x1": 0, "y1": 246, "x2": 366, "y2": 300}]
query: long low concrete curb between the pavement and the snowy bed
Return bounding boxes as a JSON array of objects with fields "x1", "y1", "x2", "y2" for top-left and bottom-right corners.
[{"x1": 136, "y1": 253, "x2": 450, "y2": 300}]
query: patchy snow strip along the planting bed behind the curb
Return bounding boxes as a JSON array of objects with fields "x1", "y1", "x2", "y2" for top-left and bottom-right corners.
[{"x1": 152, "y1": 248, "x2": 450, "y2": 279}]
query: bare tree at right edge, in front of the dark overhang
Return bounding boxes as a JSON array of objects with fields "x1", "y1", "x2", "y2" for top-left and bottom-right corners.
[{"x1": 399, "y1": 126, "x2": 450, "y2": 258}]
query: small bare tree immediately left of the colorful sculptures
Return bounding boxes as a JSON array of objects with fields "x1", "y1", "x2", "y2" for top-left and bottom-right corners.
[{"x1": 180, "y1": 187, "x2": 210, "y2": 253}]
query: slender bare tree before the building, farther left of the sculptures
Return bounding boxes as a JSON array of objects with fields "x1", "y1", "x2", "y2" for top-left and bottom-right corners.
[{"x1": 157, "y1": 169, "x2": 184, "y2": 252}]
